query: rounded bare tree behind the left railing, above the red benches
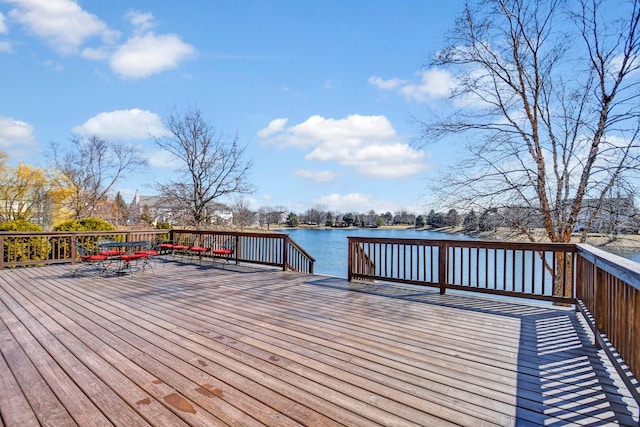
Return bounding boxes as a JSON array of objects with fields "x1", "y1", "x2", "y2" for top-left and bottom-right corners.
[{"x1": 155, "y1": 108, "x2": 253, "y2": 227}]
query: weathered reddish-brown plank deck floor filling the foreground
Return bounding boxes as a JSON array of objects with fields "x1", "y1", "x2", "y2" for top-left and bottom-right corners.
[{"x1": 0, "y1": 263, "x2": 638, "y2": 427}]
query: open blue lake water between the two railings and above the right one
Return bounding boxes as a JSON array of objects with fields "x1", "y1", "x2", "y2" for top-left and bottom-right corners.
[{"x1": 281, "y1": 228, "x2": 470, "y2": 277}]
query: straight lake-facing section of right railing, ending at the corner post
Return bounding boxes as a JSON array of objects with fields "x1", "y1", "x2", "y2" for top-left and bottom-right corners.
[{"x1": 348, "y1": 237, "x2": 576, "y2": 303}]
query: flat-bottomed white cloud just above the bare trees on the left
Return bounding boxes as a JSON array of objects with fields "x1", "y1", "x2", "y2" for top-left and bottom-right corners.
[{"x1": 71, "y1": 108, "x2": 166, "y2": 141}]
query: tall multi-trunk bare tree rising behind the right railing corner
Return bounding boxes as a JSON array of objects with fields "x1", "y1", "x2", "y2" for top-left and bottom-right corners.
[{"x1": 423, "y1": 0, "x2": 640, "y2": 246}]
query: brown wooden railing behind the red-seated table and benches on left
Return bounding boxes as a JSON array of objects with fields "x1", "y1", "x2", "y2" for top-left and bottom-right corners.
[{"x1": 0, "y1": 230, "x2": 315, "y2": 273}]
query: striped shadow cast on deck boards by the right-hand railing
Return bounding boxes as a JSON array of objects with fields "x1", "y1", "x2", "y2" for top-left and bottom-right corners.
[{"x1": 306, "y1": 278, "x2": 638, "y2": 426}]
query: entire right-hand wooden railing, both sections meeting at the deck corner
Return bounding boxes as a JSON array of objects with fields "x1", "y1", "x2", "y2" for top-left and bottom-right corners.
[{"x1": 348, "y1": 237, "x2": 640, "y2": 403}]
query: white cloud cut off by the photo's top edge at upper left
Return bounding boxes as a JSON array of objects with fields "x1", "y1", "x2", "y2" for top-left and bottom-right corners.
[{"x1": 8, "y1": 0, "x2": 118, "y2": 55}]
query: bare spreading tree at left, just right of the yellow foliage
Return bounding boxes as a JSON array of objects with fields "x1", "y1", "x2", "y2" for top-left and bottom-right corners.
[{"x1": 51, "y1": 136, "x2": 147, "y2": 218}]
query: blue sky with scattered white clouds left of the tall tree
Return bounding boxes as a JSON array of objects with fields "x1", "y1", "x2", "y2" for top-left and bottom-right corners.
[{"x1": 0, "y1": 0, "x2": 462, "y2": 213}]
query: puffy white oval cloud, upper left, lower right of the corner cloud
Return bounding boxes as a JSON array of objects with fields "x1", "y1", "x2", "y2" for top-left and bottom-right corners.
[{"x1": 110, "y1": 33, "x2": 195, "y2": 78}]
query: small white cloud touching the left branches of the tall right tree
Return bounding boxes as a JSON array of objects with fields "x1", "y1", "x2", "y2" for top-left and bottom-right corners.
[{"x1": 369, "y1": 68, "x2": 456, "y2": 102}]
